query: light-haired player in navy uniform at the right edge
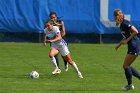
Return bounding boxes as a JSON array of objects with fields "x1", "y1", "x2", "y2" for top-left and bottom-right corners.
[{"x1": 113, "y1": 9, "x2": 140, "y2": 90}]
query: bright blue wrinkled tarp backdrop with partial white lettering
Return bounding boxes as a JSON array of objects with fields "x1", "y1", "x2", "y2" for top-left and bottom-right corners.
[{"x1": 0, "y1": 0, "x2": 140, "y2": 34}]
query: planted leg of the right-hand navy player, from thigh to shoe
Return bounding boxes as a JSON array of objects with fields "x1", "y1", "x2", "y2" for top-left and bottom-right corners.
[{"x1": 122, "y1": 54, "x2": 137, "y2": 90}]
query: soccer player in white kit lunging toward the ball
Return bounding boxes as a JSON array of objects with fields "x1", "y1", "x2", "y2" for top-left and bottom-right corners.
[{"x1": 43, "y1": 20, "x2": 83, "y2": 78}]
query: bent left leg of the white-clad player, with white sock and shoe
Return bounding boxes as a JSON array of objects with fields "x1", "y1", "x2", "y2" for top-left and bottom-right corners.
[{"x1": 49, "y1": 48, "x2": 61, "y2": 74}]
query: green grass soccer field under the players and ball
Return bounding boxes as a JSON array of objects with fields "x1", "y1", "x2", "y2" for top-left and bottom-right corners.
[{"x1": 0, "y1": 43, "x2": 140, "y2": 93}]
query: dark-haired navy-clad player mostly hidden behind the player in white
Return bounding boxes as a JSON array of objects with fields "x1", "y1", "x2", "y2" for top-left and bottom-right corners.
[{"x1": 49, "y1": 12, "x2": 68, "y2": 71}]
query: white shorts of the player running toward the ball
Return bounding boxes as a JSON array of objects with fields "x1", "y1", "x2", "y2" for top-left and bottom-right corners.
[{"x1": 51, "y1": 42, "x2": 70, "y2": 56}]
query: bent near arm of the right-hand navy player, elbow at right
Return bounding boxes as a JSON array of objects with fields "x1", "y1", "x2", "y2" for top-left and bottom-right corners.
[{"x1": 121, "y1": 26, "x2": 139, "y2": 44}]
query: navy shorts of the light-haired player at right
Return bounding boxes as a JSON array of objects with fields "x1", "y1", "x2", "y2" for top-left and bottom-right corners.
[{"x1": 127, "y1": 40, "x2": 140, "y2": 55}]
